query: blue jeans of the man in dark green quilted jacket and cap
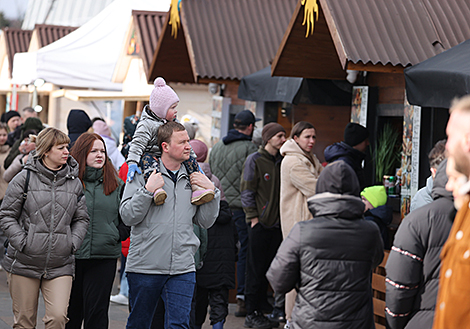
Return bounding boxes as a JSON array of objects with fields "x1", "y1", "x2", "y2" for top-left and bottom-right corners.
[{"x1": 232, "y1": 210, "x2": 248, "y2": 296}]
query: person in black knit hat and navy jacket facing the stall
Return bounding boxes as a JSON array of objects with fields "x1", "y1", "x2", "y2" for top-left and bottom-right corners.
[{"x1": 324, "y1": 122, "x2": 369, "y2": 190}]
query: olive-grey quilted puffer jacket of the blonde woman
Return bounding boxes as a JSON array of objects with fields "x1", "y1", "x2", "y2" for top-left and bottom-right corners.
[{"x1": 0, "y1": 153, "x2": 89, "y2": 279}]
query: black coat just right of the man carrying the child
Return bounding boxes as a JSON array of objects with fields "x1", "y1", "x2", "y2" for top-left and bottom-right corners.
[{"x1": 196, "y1": 200, "x2": 238, "y2": 289}]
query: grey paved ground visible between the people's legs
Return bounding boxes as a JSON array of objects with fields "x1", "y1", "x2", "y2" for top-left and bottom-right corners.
[{"x1": 0, "y1": 271, "x2": 245, "y2": 329}]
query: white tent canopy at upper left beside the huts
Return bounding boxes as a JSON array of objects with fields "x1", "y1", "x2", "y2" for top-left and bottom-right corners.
[{"x1": 12, "y1": 0, "x2": 170, "y2": 90}]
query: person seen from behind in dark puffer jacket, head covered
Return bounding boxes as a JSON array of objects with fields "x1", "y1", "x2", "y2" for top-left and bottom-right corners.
[{"x1": 267, "y1": 161, "x2": 383, "y2": 329}]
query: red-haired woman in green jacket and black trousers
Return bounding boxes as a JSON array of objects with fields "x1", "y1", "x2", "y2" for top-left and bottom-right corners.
[{"x1": 66, "y1": 133, "x2": 129, "y2": 329}]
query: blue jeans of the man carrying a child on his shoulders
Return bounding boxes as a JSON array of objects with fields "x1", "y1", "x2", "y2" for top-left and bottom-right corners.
[{"x1": 126, "y1": 272, "x2": 196, "y2": 329}]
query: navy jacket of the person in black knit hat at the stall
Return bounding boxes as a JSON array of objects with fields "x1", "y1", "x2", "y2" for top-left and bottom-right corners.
[{"x1": 324, "y1": 142, "x2": 366, "y2": 190}]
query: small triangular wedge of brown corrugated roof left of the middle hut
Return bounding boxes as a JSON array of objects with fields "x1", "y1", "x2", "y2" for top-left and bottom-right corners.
[{"x1": 132, "y1": 10, "x2": 167, "y2": 76}]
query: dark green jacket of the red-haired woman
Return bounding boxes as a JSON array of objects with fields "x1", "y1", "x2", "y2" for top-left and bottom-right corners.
[{"x1": 75, "y1": 166, "x2": 122, "y2": 259}]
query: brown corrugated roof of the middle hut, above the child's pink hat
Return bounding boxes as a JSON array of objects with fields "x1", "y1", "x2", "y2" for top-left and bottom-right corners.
[{"x1": 149, "y1": 0, "x2": 296, "y2": 82}]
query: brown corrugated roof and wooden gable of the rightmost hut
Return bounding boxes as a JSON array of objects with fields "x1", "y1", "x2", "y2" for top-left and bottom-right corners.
[{"x1": 273, "y1": 0, "x2": 470, "y2": 78}]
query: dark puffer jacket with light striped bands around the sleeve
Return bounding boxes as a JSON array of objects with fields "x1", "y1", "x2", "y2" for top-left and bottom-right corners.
[{"x1": 385, "y1": 160, "x2": 456, "y2": 329}]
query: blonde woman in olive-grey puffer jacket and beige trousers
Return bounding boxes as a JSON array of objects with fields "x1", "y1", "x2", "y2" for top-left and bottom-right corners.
[{"x1": 0, "y1": 128, "x2": 89, "y2": 329}]
